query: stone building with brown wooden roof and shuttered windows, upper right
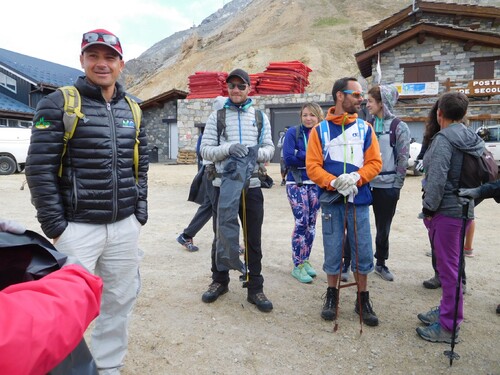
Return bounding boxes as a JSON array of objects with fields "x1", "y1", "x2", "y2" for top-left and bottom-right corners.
[{"x1": 355, "y1": 0, "x2": 500, "y2": 140}]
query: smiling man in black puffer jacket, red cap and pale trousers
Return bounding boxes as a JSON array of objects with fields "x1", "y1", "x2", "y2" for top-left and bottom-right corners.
[{"x1": 26, "y1": 29, "x2": 148, "y2": 374}]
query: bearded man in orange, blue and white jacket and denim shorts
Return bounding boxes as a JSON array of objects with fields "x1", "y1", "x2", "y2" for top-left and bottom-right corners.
[{"x1": 306, "y1": 77, "x2": 382, "y2": 326}]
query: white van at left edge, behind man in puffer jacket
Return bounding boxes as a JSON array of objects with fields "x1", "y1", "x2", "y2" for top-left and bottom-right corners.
[{"x1": 0, "y1": 126, "x2": 31, "y2": 175}]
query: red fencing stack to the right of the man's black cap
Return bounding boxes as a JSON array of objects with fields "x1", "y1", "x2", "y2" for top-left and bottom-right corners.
[{"x1": 256, "y1": 60, "x2": 312, "y2": 95}]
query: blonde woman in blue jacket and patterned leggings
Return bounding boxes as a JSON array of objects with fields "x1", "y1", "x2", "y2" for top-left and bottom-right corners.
[{"x1": 283, "y1": 103, "x2": 324, "y2": 283}]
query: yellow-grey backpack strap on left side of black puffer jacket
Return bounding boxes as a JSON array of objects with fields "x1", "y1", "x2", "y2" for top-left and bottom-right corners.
[{"x1": 58, "y1": 86, "x2": 85, "y2": 177}]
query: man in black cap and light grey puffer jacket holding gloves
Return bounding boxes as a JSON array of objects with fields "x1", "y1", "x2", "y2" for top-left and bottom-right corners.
[{"x1": 200, "y1": 69, "x2": 274, "y2": 312}]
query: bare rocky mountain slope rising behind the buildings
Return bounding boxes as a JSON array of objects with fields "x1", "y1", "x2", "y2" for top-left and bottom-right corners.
[{"x1": 123, "y1": 0, "x2": 500, "y2": 100}]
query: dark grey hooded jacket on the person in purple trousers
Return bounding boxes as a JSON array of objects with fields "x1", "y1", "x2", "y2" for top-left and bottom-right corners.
[{"x1": 423, "y1": 123, "x2": 484, "y2": 218}]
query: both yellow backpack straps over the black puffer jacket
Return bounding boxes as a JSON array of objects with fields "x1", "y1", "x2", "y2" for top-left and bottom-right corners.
[{"x1": 58, "y1": 86, "x2": 141, "y2": 182}]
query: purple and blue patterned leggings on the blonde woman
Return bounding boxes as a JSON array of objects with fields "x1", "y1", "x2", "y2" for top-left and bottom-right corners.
[{"x1": 286, "y1": 184, "x2": 320, "y2": 267}]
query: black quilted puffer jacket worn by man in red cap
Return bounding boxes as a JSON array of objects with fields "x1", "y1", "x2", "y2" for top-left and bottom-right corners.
[{"x1": 26, "y1": 77, "x2": 149, "y2": 238}]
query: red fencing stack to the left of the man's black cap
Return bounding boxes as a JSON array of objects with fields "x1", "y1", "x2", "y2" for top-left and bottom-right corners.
[{"x1": 187, "y1": 72, "x2": 227, "y2": 99}]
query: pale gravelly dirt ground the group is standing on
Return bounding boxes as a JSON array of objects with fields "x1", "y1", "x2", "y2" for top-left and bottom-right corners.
[{"x1": 0, "y1": 164, "x2": 500, "y2": 375}]
